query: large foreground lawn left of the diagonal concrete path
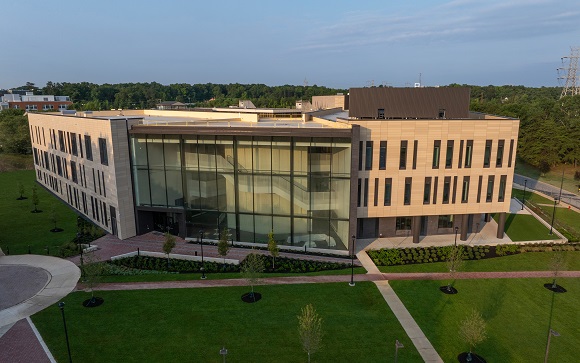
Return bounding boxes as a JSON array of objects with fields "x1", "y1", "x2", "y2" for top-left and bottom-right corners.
[{"x1": 33, "y1": 282, "x2": 422, "y2": 363}]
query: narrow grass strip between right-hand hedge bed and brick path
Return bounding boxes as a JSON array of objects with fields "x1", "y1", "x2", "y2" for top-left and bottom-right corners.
[{"x1": 379, "y1": 251, "x2": 580, "y2": 273}]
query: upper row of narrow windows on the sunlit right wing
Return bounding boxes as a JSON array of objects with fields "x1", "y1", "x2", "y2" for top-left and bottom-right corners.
[{"x1": 358, "y1": 139, "x2": 514, "y2": 170}]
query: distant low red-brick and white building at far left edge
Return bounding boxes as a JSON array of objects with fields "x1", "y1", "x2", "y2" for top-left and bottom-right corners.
[{"x1": 0, "y1": 90, "x2": 72, "y2": 111}]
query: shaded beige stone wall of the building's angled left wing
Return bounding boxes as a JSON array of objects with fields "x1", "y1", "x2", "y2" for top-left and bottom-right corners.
[{"x1": 28, "y1": 113, "x2": 137, "y2": 239}]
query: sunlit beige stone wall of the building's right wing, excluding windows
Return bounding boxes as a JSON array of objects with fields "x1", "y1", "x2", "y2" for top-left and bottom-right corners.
[{"x1": 350, "y1": 117, "x2": 519, "y2": 218}]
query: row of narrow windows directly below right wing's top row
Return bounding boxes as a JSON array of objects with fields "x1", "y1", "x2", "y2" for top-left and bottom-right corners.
[{"x1": 357, "y1": 175, "x2": 507, "y2": 207}]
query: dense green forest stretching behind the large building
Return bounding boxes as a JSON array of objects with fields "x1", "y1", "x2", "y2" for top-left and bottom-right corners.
[{"x1": 0, "y1": 82, "x2": 580, "y2": 171}]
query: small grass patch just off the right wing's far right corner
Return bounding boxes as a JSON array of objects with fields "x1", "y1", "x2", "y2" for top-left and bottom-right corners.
[{"x1": 494, "y1": 213, "x2": 560, "y2": 242}]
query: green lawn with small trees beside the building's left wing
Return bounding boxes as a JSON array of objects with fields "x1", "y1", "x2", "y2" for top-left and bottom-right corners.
[{"x1": 0, "y1": 170, "x2": 77, "y2": 254}]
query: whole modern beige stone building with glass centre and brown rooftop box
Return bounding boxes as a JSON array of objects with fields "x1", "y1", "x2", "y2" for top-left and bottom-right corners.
[{"x1": 28, "y1": 87, "x2": 519, "y2": 253}]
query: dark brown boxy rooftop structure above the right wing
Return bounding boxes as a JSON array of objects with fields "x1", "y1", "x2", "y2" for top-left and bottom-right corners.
[{"x1": 349, "y1": 87, "x2": 470, "y2": 119}]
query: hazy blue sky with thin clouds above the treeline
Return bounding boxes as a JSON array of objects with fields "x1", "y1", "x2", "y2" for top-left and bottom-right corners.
[{"x1": 0, "y1": 0, "x2": 580, "y2": 88}]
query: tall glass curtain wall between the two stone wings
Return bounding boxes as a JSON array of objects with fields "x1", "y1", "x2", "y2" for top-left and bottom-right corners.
[{"x1": 131, "y1": 135, "x2": 351, "y2": 250}]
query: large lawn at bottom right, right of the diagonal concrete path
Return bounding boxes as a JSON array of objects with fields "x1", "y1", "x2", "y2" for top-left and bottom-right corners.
[{"x1": 390, "y1": 279, "x2": 580, "y2": 363}]
